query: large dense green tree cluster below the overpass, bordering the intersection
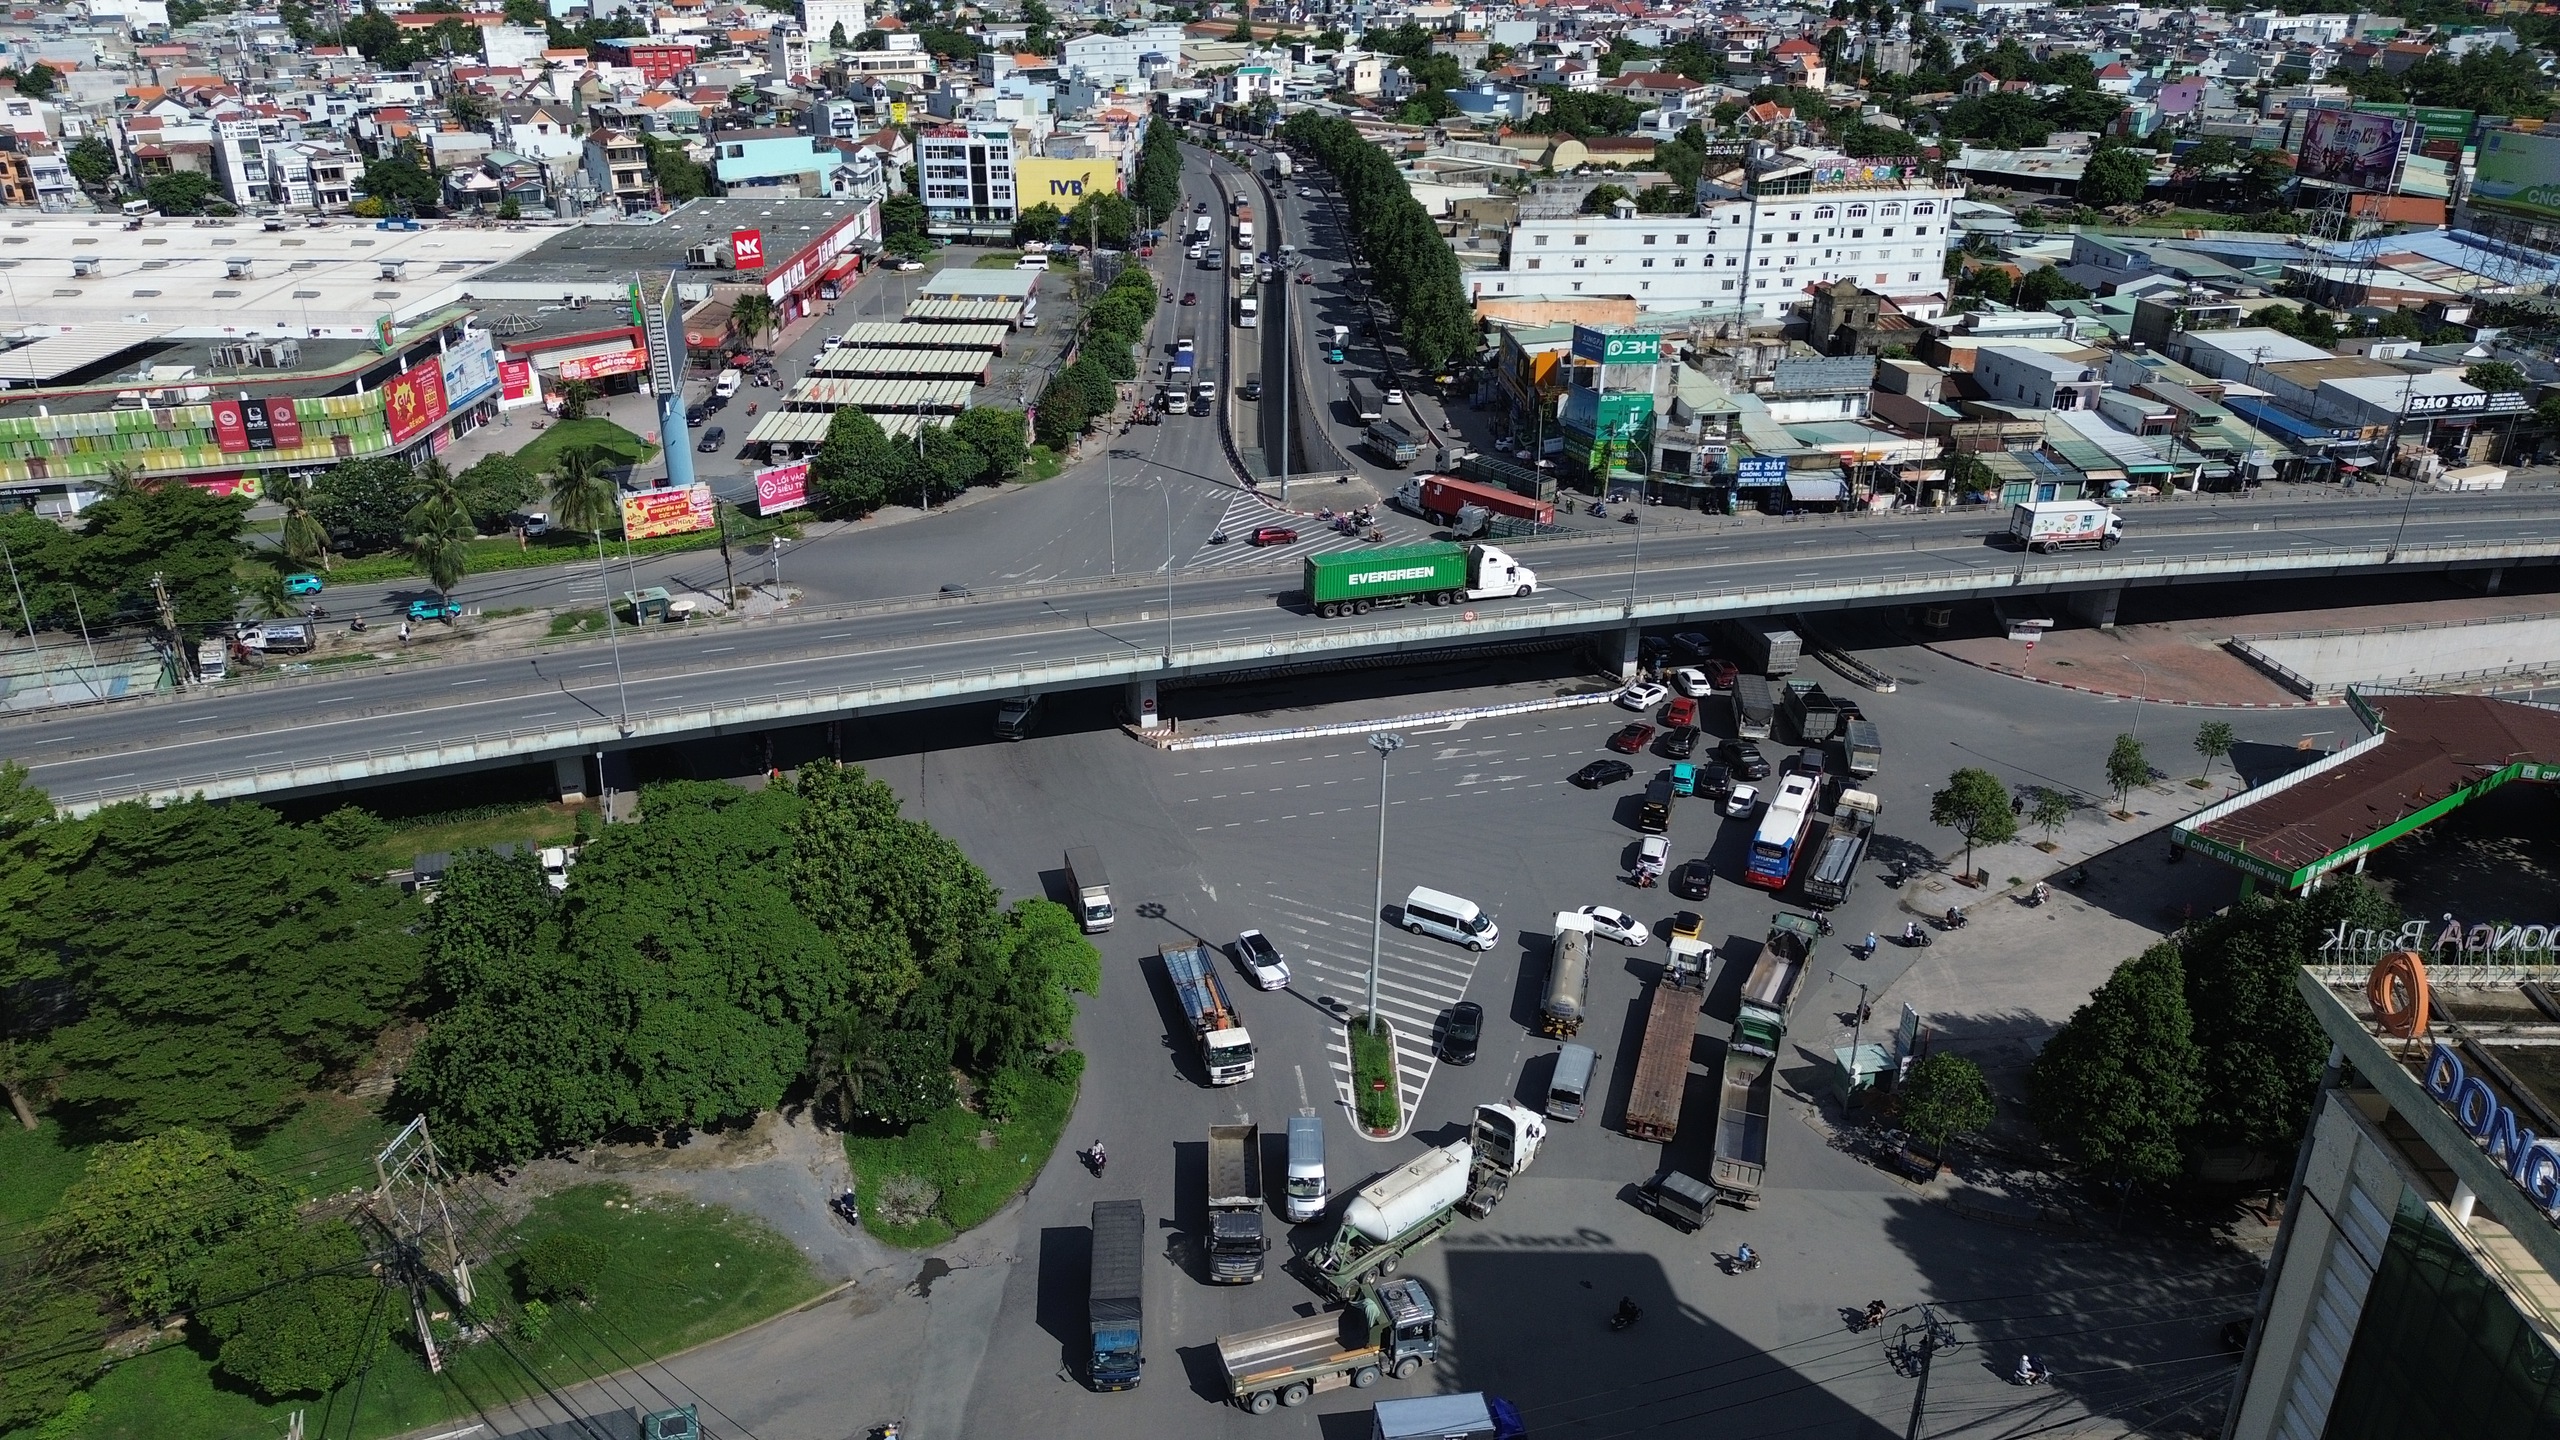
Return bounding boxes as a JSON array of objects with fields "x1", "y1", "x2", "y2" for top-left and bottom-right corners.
[{"x1": 399, "y1": 766, "x2": 1101, "y2": 1166}]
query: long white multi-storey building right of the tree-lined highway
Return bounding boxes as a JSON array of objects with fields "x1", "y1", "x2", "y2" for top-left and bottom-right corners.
[{"x1": 1467, "y1": 151, "x2": 1964, "y2": 320}]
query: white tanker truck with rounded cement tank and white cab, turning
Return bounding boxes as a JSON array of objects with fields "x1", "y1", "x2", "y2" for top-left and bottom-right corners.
[{"x1": 1306, "y1": 1104, "x2": 1546, "y2": 1304}]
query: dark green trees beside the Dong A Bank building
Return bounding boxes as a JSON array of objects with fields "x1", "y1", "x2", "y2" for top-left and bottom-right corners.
[{"x1": 2028, "y1": 879, "x2": 2399, "y2": 1181}]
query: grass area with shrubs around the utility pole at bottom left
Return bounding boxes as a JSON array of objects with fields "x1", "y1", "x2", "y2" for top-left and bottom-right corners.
[{"x1": 79, "y1": 1186, "x2": 822, "y2": 1440}]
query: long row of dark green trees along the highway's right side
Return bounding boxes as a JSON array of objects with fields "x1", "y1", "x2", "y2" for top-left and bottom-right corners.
[{"x1": 1280, "y1": 110, "x2": 1475, "y2": 374}]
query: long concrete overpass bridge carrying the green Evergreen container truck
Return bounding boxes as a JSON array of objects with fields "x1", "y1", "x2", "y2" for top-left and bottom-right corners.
[{"x1": 0, "y1": 495, "x2": 2560, "y2": 812}]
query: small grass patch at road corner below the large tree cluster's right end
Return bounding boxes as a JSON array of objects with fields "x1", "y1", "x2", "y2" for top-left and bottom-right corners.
[{"x1": 845, "y1": 1051, "x2": 1085, "y2": 1250}]
